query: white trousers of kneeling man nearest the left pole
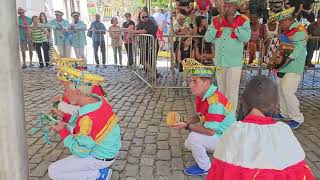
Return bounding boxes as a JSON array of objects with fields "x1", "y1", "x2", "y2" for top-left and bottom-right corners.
[{"x1": 48, "y1": 155, "x2": 114, "y2": 180}]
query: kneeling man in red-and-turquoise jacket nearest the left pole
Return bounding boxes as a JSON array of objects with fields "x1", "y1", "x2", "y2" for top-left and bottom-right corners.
[{"x1": 48, "y1": 68, "x2": 121, "y2": 180}]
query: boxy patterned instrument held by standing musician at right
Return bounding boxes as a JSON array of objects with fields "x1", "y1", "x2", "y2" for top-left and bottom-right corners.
[{"x1": 265, "y1": 34, "x2": 294, "y2": 69}]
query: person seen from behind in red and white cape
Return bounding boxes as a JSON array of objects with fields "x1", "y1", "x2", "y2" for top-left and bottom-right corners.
[{"x1": 207, "y1": 76, "x2": 314, "y2": 180}]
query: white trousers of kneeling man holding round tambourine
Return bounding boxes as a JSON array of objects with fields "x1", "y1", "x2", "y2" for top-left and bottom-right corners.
[{"x1": 184, "y1": 132, "x2": 220, "y2": 171}]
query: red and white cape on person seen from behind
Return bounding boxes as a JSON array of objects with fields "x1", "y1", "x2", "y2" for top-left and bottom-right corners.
[{"x1": 207, "y1": 115, "x2": 314, "y2": 180}]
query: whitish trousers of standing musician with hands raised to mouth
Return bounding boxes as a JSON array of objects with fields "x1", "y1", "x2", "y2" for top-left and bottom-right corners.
[{"x1": 216, "y1": 67, "x2": 242, "y2": 114}]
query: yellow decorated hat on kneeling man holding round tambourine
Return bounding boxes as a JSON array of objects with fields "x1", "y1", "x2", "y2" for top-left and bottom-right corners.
[{"x1": 182, "y1": 58, "x2": 216, "y2": 77}]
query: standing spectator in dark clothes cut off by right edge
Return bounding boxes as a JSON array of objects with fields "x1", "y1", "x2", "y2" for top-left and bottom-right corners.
[{"x1": 305, "y1": 14, "x2": 320, "y2": 67}]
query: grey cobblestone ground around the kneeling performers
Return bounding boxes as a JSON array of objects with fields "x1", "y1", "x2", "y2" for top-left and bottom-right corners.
[{"x1": 23, "y1": 67, "x2": 320, "y2": 180}]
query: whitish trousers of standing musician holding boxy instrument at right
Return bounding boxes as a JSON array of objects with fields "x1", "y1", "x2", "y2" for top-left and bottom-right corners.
[{"x1": 277, "y1": 73, "x2": 304, "y2": 123}]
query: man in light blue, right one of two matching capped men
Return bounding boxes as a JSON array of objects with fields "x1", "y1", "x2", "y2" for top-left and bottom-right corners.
[{"x1": 71, "y1": 12, "x2": 87, "y2": 60}]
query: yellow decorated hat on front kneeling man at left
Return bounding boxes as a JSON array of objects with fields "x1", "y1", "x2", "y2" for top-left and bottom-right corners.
[{"x1": 57, "y1": 66, "x2": 104, "y2": 86}]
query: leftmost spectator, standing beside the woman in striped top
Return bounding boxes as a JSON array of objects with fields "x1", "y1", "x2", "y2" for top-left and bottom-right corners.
[{"x1": 18, "y1": 7, "x2": 34, "y2": 69}]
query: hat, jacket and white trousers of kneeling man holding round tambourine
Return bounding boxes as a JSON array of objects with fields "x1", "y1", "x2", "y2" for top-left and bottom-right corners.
[{"x1": 182, "y1": 59, "x2": 236, "y2": 172}]
